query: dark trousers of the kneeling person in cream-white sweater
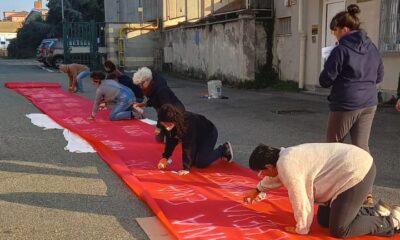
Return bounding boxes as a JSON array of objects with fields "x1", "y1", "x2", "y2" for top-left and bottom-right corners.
[{"x1": 317, "y1": 163, "x2": 394, "y2": 238}]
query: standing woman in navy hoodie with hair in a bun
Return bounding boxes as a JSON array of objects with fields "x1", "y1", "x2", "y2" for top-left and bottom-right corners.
[{"x1": 319, "y1": 4, "x2": 383, "y2": 152}]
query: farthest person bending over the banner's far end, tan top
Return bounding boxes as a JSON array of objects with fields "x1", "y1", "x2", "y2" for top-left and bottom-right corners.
[{"x1": 59, "y1": 63, "x2": 90, "y2": 92}]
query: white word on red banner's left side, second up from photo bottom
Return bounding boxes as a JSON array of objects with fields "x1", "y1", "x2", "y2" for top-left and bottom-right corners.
[{"x1": 158, "y1": 185, "x2": 207, "y2": 205}]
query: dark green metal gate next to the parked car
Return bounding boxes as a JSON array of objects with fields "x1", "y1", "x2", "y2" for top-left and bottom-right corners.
[{"x1": 63, "y1": 21, "x2": 106, "y2": 70}]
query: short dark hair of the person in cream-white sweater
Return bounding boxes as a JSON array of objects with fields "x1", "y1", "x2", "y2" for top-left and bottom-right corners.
[{"x1": 249, "y1": 144, "x2": 281, "y2": 171}]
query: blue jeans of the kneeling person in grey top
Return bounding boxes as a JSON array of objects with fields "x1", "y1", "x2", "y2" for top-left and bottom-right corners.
[{"x1": 110, "y1": 88, "x2": 135, "y2": 121}]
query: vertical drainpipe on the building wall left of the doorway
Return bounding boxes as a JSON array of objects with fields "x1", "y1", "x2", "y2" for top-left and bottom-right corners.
[{"x1": 297, "y1": 0, "x2": 307, "y2": 89}]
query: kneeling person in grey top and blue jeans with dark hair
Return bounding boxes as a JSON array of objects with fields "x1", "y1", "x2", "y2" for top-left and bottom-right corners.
[{"x1": 89, "y1": 72, "x2": 139, "y2": 121}]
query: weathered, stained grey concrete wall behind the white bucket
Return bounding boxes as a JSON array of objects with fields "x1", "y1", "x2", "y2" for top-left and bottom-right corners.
[{"x1": 163, "y1": 15, "x2": 266, "y2": 81}]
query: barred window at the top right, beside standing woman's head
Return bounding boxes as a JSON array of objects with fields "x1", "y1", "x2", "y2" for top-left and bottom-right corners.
[{"x1": 379, "y1": 0, "x2": 400, "y2": 53}]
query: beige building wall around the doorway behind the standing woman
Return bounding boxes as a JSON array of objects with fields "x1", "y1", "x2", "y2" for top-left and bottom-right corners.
[{"x1": 274, "y1": 0, "x2": 400, "y2": 95}]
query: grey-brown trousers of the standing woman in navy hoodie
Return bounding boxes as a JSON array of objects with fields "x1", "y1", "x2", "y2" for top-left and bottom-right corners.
[{"x1": 326, "y1": 106, "x2": 376, "y2": 152}]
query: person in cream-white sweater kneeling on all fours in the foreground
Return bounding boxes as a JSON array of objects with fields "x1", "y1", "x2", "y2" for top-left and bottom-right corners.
[{"x1": 244, "y1": 143, "x2": 400, "y2": 238}]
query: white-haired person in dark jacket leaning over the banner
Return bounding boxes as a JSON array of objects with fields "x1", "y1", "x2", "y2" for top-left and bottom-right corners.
[{"x1": 132, "y1": 67, "x2": 185, "y2": 142}]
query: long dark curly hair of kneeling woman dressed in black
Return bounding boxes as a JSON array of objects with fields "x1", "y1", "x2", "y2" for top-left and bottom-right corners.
[{"x1": 158, "y1": 104, "x2": 186, "y2": 139}]
